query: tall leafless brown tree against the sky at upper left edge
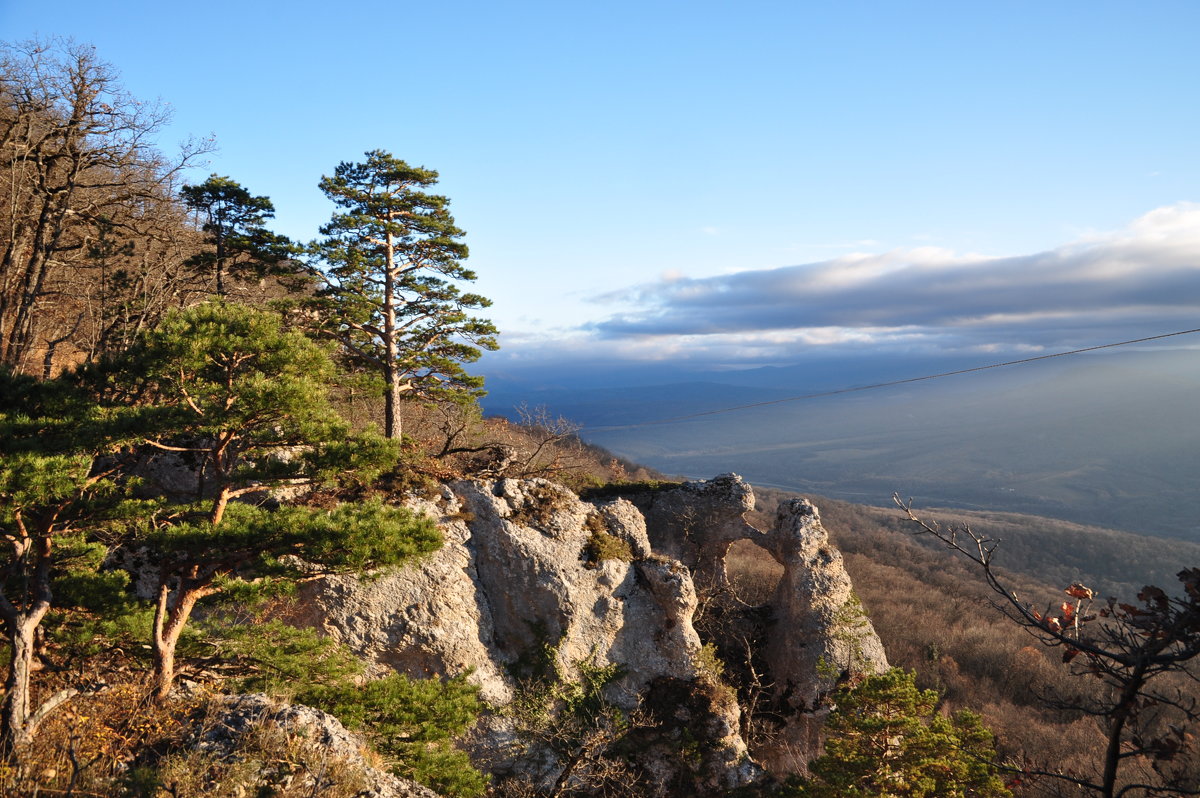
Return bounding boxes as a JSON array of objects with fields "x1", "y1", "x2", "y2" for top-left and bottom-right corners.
[{"x1": 0, "y1": 40, "x2": 206, "y2": 371}]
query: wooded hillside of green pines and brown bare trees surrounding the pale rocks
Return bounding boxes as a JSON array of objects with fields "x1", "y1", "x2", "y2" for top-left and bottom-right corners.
[{"x1": 7, "y1": 35, "x2": 1200, "y2": 798}]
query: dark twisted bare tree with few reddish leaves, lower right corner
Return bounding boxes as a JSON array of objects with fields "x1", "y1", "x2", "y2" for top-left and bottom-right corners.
[{"x1": 893, "y1": 496, "x2": 1200, "y2": 798}]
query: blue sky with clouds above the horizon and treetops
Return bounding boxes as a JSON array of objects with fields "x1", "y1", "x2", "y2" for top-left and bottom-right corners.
[{"x1": 0, "y1": 0, "x2": 1200, "y2": 379}]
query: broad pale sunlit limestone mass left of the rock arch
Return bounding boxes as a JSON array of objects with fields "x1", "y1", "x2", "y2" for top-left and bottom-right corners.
[{"x1": 296, "y1": 480, "x2": 752, "y2": 786}]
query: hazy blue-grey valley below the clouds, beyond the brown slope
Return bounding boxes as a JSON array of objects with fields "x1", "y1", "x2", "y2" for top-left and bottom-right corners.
[{"x1": 485, "y1": 350, "x2": 1200, "y2": 541}]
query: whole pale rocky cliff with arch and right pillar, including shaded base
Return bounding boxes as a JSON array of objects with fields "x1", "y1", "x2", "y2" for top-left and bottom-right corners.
[{"x1": 296, "y1": 475, "x2": 887, "y2": 793}]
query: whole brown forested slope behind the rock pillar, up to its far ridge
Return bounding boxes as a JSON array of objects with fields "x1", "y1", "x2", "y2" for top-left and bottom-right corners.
[{"x1": 730, "y1": 488, "x2": 1200, "y2": 796}]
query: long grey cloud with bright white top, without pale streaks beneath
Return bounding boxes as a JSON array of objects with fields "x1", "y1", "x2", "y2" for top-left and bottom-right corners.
[{"x1": 593, "y1": 204, "x2": 1200, "y2": 338}]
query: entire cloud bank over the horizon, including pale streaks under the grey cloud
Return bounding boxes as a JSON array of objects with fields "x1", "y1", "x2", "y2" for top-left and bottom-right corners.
[{"x1": 484, "y1": 203, "x2": 1200, "y2": 367}]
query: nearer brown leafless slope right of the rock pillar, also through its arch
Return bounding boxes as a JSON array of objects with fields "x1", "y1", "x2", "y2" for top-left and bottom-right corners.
[{"x1": 727, "y1": 488, "x2": 1152, "y2": 796}]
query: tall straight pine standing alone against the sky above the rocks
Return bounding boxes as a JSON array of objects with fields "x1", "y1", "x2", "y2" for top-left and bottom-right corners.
[{"x1": 311, "y1": 150, "x2": 497, "y2": 438}]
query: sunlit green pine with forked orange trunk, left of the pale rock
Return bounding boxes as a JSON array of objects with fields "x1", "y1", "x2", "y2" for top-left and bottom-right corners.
[{"x1": 84, "y1": 300, "x2": 440, "y2": 700}]
